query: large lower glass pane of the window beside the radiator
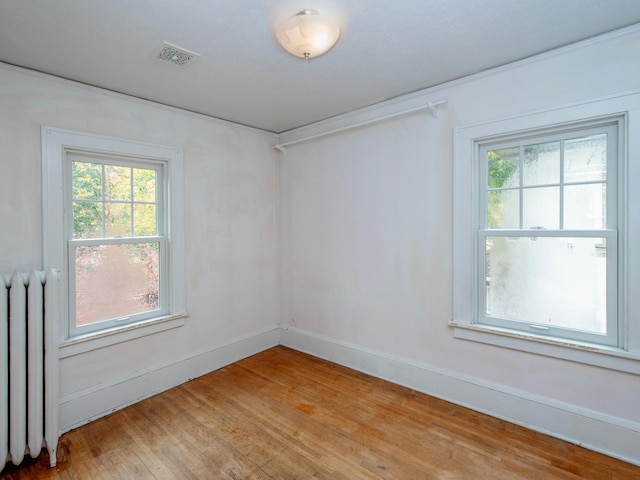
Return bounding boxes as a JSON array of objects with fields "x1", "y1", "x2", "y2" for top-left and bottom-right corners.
[{"x1": 75, "y1": 243, "x2": 159, "y2": 325}]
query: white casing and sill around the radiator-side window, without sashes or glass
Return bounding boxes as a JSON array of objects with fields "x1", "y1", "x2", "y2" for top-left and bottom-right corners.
[{"x1": 42, "y1": 127, "x2": 187, "y2": 358}]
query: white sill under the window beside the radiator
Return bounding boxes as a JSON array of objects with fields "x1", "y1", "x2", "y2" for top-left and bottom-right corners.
[{"x1": 59, "y1": 313, "x2": 189, "y2": 359}]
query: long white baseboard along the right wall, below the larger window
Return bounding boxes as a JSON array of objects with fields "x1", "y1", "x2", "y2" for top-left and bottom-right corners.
[{"x1": 280, "y1": 326, "x2": 640, "y2": 465}]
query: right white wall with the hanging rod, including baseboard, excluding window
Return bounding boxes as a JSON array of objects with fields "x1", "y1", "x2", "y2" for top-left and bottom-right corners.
[{"x1": 280, "y1": 28, "x2": 640, "y2": 463}]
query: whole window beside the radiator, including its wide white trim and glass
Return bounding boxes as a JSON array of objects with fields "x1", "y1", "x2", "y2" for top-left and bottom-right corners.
[{"x1": 42, "y1": 127, "x2": 186, "y2": 344}]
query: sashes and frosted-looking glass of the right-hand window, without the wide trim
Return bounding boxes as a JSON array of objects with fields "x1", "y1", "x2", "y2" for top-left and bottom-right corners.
[{"x1": 476, "y1": 121, "x2": 619, "y2": 345}]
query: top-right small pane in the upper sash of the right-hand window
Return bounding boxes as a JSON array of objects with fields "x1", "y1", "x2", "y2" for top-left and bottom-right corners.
[{"x1": 564, "y1": 133, "x2": 607, "y2": 183}]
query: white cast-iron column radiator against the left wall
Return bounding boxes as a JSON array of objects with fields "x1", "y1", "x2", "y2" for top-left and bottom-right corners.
[{"x1": 0, "y1": 269, "x2": 60, "y2": 471}]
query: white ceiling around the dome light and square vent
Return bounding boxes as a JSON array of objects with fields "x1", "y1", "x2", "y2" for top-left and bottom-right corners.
[{"x1": 0, "y1": 0, "x2": 640, "y2": 133}]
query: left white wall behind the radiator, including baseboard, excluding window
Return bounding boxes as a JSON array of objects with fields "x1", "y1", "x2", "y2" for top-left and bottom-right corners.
[{"x1": 0, "y1": 66, "x2": 278, "y2": 430}]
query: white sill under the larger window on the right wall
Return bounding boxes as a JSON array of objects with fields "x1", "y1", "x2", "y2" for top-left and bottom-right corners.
[{"x1": 449, "y1": 322, "x2": 640, "y2": 375}]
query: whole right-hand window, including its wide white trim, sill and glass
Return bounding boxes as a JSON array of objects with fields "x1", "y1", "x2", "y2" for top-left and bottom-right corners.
[{"x1": 450, "y1": 92, "x2": 640, "y2": 373}]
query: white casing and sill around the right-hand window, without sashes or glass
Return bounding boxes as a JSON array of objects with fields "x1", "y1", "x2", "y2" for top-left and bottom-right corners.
[{"x1": 450, "y1": 91, "x2": 640, "y2": 374}]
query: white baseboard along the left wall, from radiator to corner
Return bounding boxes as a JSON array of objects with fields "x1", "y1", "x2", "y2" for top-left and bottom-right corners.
[{"x1": 60, "y1": 327, "x2": 280, "y2": 433}]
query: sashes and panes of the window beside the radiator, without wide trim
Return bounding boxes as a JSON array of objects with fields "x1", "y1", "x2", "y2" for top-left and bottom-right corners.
[{"x1": 65, "y1": 149, "x2": 168, "y2": 337}]
